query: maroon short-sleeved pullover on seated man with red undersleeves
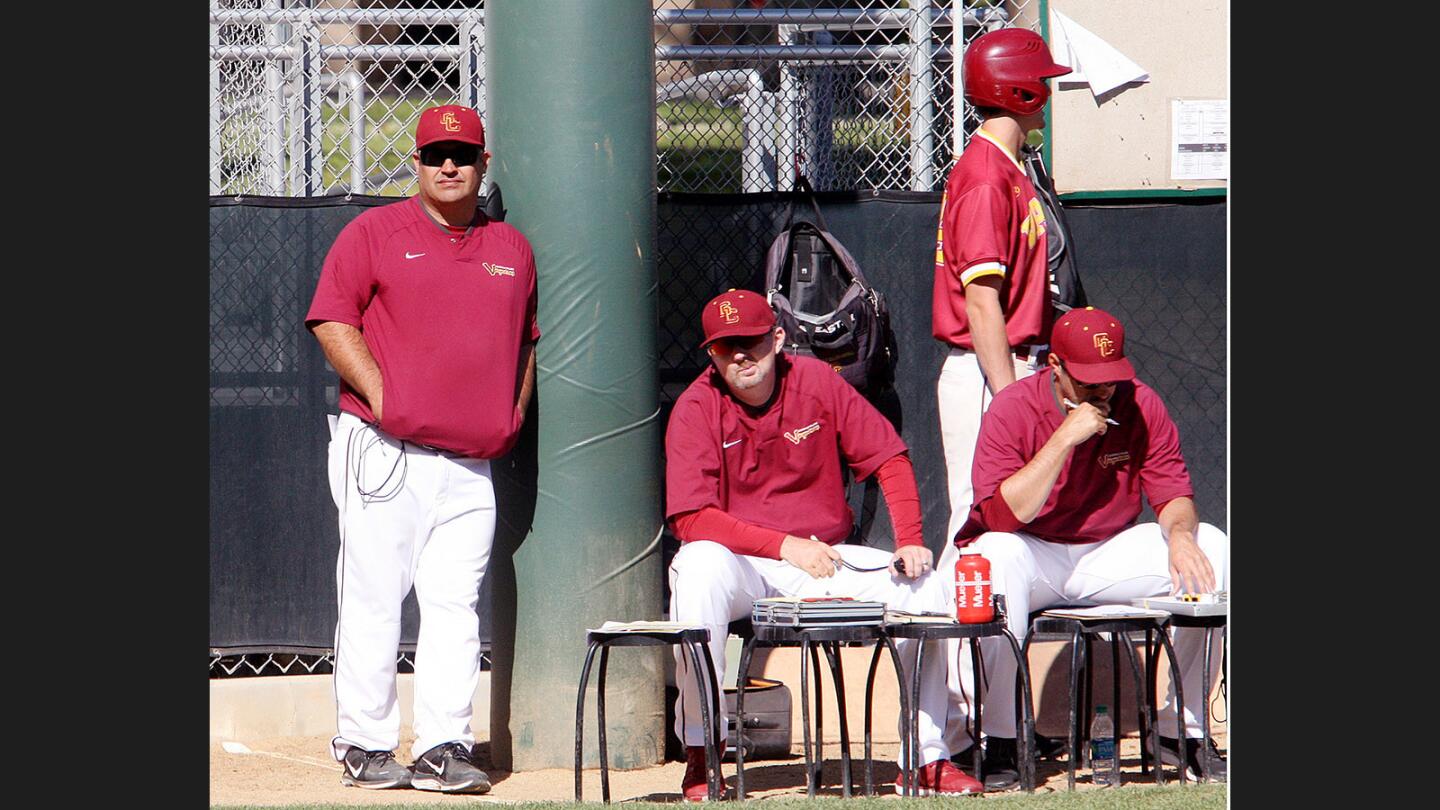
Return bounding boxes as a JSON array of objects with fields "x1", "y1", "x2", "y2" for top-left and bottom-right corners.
[{"x1": 665, "y1": 353, "x2": 906, "y2": 543}]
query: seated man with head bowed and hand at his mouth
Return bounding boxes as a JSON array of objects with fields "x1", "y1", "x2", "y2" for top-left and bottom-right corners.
[{"x1": 956, "y1": 307, "x2": 1230, "y2": 781}]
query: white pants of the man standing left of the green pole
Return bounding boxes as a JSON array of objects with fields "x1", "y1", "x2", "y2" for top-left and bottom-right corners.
[{"x1": 330, "y1": 414, "x2": 495, "y2": 760}]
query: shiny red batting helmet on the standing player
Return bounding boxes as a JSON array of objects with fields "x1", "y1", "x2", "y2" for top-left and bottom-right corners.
[{"x1": 962, "y1": 29, "x2": 1070, "y2": 115}]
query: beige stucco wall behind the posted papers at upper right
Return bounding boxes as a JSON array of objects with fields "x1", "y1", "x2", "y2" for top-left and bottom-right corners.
[{"x1": 1050, "y1": 0, "x2": 1230, "y2": 193}]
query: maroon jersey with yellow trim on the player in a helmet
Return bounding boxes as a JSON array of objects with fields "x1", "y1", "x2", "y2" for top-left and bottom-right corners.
[{"x1": 930, "y1": 130, "x2": 1053, "y2": 350}]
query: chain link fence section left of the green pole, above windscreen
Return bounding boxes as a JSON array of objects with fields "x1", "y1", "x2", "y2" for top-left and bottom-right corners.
[{"x1": 210, "y1": 0, "x2": 485, "y2": 196}]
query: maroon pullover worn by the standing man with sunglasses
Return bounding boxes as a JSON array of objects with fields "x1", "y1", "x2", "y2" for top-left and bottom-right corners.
[{"x1": 305, "y1": 197, "x2": 540, "y2": 458}]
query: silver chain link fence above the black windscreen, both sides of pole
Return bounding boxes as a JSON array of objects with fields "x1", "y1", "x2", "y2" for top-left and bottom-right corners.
[{"x1": 209, "y1": 0, "x2": 1041, "y2": 196}]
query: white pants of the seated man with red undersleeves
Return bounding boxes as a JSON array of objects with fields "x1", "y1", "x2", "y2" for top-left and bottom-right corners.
[{"x1": 670, "y1": 540, "x2": 950, "y2": 762}]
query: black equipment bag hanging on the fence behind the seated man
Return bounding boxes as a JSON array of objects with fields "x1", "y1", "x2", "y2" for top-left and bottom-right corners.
[{"x1": 765, "y1": 176, "x2": 897, "y2": 392}]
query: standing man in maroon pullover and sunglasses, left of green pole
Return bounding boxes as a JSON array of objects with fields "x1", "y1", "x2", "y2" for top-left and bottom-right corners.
[{"x1": 305, "y1": 105, "x2": 540, "y2": 793}]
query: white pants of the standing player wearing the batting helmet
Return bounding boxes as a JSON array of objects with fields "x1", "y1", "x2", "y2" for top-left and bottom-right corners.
[{"x1": 935, "y1": 347, "x2": 1038, "y2": 751}]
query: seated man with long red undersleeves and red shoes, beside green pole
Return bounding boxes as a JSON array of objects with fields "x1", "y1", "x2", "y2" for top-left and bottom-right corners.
[{"x1": 665, "y1": 290, "x2": 981, "y2": 801}]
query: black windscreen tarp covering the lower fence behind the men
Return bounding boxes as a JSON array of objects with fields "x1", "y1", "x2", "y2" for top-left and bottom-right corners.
[{"x1": 209, "y1": 192, "x2": 1227, "y2": 649}]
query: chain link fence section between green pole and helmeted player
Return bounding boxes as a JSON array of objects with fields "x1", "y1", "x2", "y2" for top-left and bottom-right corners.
[{"x1": 655, "y1": 0, "x2": 1040, "y2": 192}]
